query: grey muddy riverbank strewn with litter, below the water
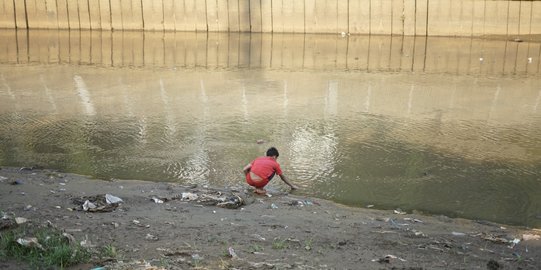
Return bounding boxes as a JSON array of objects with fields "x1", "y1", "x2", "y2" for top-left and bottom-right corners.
[{"x1": 0, "y1": 167, "x2": 541, "y2": 269}]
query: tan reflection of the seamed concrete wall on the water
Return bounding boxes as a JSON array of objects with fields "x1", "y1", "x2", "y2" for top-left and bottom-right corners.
[{"x1": 0, "y1": 29, "x2": 541, "y2": 76}]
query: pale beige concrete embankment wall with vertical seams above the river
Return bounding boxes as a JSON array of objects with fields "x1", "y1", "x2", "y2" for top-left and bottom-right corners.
[{"x1": 0, "y1": 0, "x2": 541, "y2": 36}]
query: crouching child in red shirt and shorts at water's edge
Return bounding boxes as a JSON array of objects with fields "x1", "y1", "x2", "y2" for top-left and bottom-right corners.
[{"x1": 243, "y1": 147, "x2": 297, "y2": 194}]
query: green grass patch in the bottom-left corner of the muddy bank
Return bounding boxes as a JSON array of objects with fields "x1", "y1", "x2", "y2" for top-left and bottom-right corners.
[{"x1": 0, "y1": 225, "x2": 91, "y2": 269}]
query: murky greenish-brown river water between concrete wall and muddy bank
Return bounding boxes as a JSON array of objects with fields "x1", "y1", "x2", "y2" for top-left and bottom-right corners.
[{"x1": 0, "y1": 30, "x2": 541, "y2": 227}]
